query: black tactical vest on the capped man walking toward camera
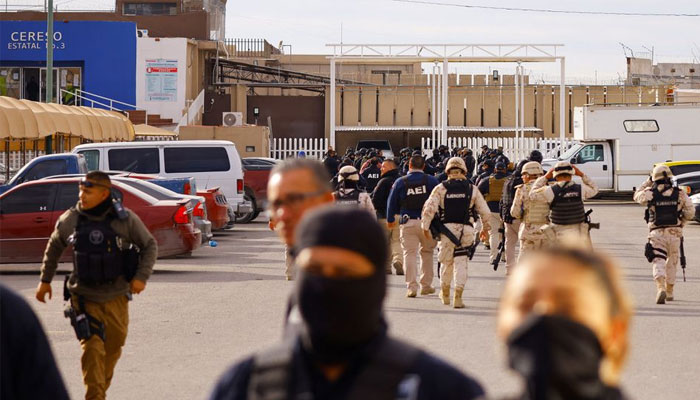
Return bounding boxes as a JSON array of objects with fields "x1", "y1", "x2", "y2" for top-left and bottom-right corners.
[{"x1": 72, "y1": 215, "x2": 124, "y2": 285}]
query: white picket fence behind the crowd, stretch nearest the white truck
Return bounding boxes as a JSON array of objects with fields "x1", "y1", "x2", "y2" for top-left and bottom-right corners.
[{"x1": 421, "y1": 137, "x2": 578, "y2": 160}]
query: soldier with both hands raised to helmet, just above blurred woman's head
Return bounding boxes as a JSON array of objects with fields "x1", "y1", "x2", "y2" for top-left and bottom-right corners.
[{"x1": 530, "y1": 161, "x2": 598, "y2": 245}]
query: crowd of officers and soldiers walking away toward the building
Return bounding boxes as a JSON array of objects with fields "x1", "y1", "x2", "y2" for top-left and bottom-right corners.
[{"x1": 324, "y1": 146, "x2": 598, "y2": 308}]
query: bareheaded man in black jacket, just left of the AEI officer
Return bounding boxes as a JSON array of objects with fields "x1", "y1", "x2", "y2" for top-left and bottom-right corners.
[{"x1": 371, "y1": 160, "x2": 403, "y2": 275}]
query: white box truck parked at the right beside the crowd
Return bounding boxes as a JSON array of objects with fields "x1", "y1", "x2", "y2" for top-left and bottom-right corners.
[{"x1": 542, "y1": 104, "x2": 700, "y2": 192}]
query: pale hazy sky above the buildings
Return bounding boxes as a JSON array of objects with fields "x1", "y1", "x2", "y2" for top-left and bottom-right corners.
[{"x1": 6, "y1": 0, "x2": 700, "y2": 83}]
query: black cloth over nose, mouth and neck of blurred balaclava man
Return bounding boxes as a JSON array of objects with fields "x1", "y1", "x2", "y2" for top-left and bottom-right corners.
[{"x1": 297, "y1": 273, "x2": 386, "y2": 363}]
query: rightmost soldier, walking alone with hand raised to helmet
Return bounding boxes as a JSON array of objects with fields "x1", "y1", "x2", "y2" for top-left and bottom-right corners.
[{"x1": 634, "y1": 165, "x2": 695, "y2": 304}]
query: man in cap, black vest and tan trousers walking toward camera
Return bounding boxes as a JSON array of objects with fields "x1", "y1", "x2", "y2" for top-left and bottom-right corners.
[{"x1": 36, "y1": 171, "x2": 158, "y2": 399}]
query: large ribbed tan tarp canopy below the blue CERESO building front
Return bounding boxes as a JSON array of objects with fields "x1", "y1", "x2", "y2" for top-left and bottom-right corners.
[{"x1": 0, "y1": 96, "x2": 134, "y2": 142}]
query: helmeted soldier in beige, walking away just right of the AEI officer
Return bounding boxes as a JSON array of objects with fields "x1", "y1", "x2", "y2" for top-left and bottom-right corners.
[{"x1": 421, "y1": 157, "x2": 491, "y2": 308}]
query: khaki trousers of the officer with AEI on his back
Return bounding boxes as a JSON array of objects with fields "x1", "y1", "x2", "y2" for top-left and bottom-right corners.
[{"x1": 400, "y1": 219, "x2": 436, "y2": 290}]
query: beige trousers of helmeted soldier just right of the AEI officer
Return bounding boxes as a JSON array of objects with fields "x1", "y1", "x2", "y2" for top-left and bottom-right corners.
[{"x1": 438, "y1": 223, "x2": 475, "y2": 289}]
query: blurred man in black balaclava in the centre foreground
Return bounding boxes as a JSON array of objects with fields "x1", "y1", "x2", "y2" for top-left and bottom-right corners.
[{"x1": 206, "y1": 207, "x2": 484, "y2": 400}]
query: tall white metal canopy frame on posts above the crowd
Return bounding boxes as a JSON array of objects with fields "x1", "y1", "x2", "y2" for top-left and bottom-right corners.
[{"x1": 326, "y1": 43, "x2": 566, "y2": 158}]
